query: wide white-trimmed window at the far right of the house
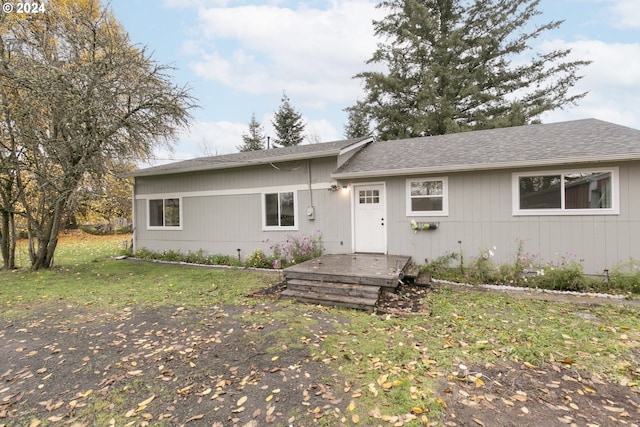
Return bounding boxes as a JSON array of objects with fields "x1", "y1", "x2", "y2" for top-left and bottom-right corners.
[{"x1": 512, "y1": 168, "x2": 620, "y2": 215}]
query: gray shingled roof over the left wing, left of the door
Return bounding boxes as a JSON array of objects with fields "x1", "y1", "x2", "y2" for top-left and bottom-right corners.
[{"x1": 126, "y1": 137, "x2": 371, "y2": 177}]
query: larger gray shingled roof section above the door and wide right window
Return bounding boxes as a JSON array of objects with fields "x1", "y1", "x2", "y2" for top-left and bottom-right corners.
[{"x1": 332, "y1": 119, "x2": 640, "y2": 179}]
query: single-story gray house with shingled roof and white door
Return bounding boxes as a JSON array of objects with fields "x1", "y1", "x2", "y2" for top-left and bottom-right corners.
[{"x1": 132, "y1": 119, "x2": 640, "y2": 274}]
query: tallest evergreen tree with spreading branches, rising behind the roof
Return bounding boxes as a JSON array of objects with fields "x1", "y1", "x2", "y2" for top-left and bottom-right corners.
[{"x1": 348, "y1": 0, "x2": 589, "y2": 139}]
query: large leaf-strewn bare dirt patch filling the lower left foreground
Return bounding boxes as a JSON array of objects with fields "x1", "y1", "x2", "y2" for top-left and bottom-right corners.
[{"x1": 0, "y1": 305, "x2": 348, "y2": 426}]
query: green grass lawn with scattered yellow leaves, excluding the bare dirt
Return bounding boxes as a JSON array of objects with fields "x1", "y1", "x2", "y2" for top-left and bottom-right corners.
[{"x1": 0, "y1": 235, "x2": 640, "y2": 425}]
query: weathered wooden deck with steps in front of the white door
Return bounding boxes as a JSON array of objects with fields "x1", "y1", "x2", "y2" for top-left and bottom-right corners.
[{"x1": 282, "y1": 254, "x2": 411, "y2": 310}]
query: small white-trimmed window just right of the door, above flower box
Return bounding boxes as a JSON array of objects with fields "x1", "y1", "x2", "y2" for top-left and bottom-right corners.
[{"x1": 406, "y1": 177, "x2": 449, "y2": 216}]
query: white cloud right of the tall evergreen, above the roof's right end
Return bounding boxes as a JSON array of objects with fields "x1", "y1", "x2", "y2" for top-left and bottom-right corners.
[{"x1": 544, "y1": 40, "x2": 640, "y2": 128}]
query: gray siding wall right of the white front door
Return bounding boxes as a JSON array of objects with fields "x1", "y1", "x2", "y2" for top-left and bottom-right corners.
[{"x1": 380, "y1": 162, "x2": 640, "y2": 274}]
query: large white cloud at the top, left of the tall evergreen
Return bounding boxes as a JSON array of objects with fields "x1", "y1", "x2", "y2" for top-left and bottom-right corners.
[{"x1": 188, "y1": 0, "x2": 380, "y2": 109}]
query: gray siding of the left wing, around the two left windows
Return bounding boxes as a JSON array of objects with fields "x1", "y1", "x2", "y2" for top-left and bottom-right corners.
[{"x1": 135, "y1": 157, "x2": 351, "y2": 258}]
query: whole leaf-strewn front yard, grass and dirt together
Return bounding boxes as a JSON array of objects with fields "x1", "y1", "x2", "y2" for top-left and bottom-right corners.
[{"x1": 0, "y1": 235, "x2": 640, "y2": 426}]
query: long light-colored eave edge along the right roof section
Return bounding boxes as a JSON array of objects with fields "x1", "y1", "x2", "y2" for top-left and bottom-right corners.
[{"x1": 331, "y1": 153, "x2": 640, "y2": 180}]
